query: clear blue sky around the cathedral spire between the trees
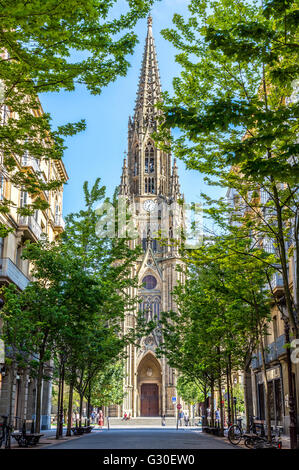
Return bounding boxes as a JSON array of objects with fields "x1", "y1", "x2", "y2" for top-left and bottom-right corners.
[{"x1": 40, "y1": 0, "x2": 225, "y2": 215}]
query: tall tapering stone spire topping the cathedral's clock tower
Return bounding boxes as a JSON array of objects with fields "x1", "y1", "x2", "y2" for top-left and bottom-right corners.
[{"x1": 134, "y1": 16, "x2": 161, "y2": 127}]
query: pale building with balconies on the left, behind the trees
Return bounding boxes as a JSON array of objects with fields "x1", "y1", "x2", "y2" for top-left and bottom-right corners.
[{"x1": 0, "y1": 92, "x2": 68, "y2": 429}]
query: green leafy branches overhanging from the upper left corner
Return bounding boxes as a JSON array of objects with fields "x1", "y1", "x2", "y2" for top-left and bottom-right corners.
[{"x1": 0, "y1": 0, "x2": 154, "y2": 236}]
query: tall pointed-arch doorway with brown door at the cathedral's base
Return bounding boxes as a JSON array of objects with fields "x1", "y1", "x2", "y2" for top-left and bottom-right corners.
[{"x1": 137, "y1": 352, "x2": 162, "y2": 416}]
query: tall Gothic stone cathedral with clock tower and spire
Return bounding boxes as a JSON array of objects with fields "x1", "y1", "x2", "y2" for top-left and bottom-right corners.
[{"x1": 113, "y1": 17, "x2": 184, "y2": 417}]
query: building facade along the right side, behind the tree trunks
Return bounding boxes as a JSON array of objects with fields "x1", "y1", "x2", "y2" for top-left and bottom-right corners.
[{"x1": 227, "y1": 184, "x2": 299, "y2": 433}]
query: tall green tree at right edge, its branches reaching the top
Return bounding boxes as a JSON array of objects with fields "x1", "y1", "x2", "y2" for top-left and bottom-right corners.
[{"x1": 158, "y1": 0, "x2": 299, "y2": 447}]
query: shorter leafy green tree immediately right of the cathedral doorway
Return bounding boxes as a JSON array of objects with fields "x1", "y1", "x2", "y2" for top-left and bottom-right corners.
[{"x1": 161, "y1": 237, "x2": 270, "y2": 436}]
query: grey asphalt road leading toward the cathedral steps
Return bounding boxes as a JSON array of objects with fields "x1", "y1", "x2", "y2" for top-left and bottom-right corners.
[{"x1": 44, "y1": 428, "x2": 234, "y2": 450}]
